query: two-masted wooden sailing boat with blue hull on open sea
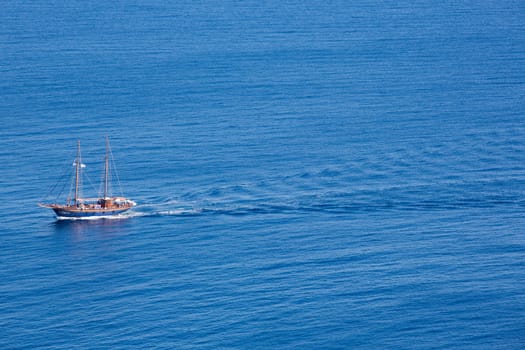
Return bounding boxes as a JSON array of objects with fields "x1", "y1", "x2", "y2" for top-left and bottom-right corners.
[{"x1": 39, "y1": 137, "x2": 136, "y2": 219}]
